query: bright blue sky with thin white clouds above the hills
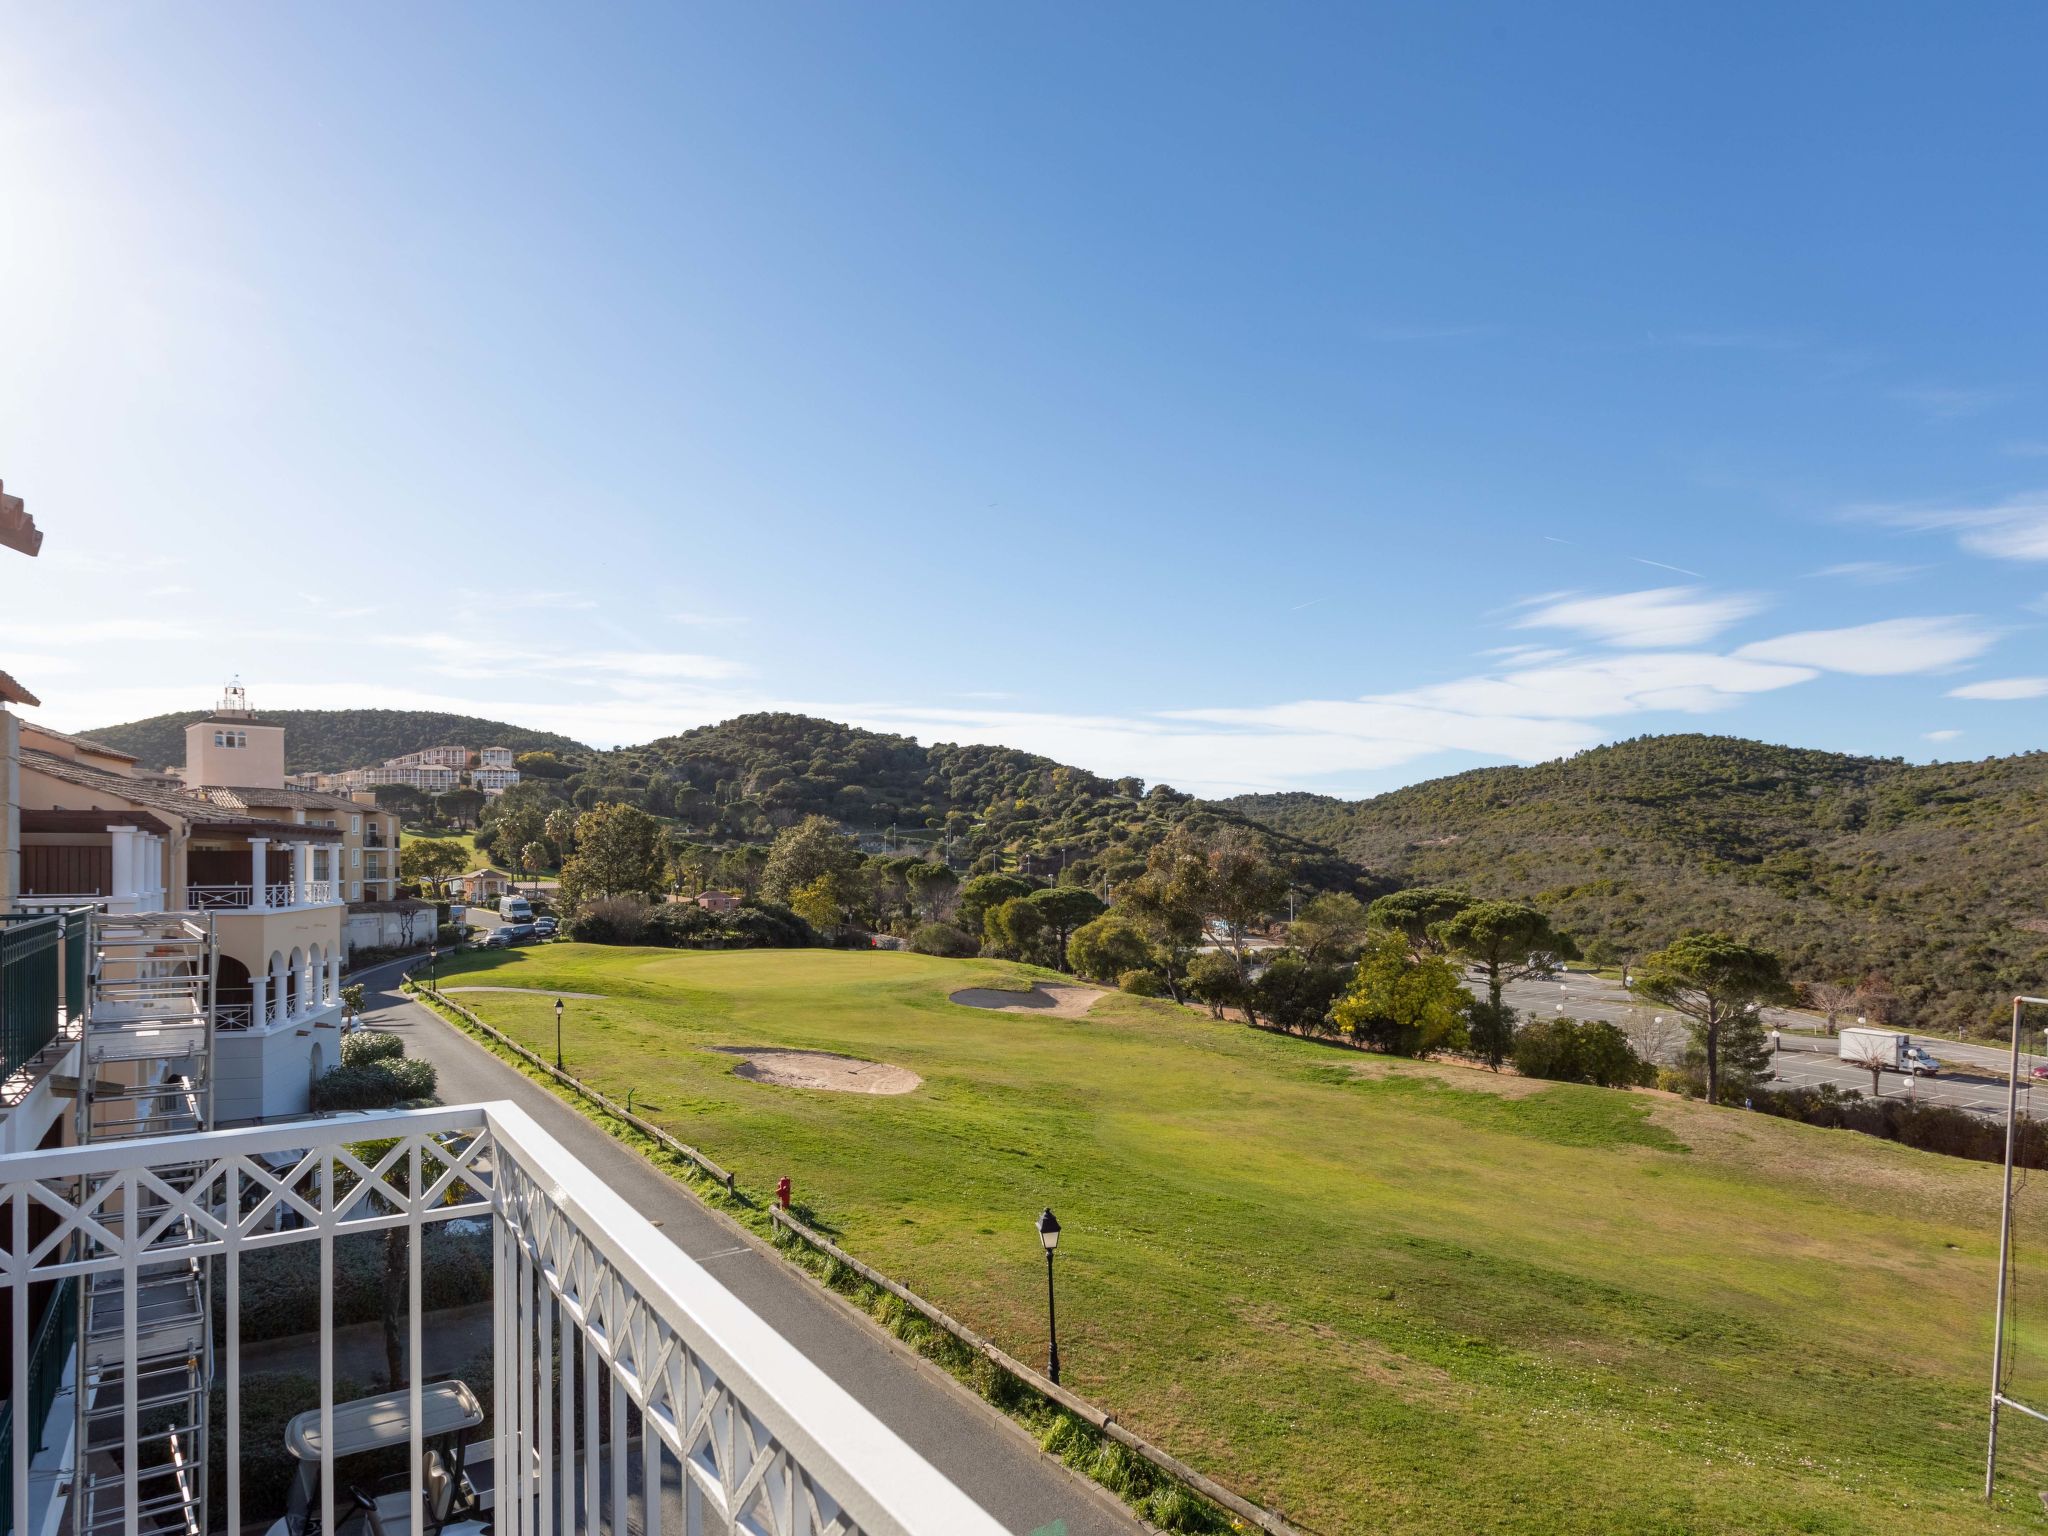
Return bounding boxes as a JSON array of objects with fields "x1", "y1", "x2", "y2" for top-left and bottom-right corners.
[{"x1": 0, "y1": 4, "x2": 2048, "y2": 793}]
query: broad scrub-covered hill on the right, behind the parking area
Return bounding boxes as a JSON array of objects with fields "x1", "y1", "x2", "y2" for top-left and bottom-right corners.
[{"x1": 1225, "y1": 735, "x2": 2048, "y2": 1028}]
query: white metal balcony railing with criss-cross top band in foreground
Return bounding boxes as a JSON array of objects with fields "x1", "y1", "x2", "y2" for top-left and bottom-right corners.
[{"x1": 0, "y1": 1104, "x2": 1004, "y2": 1536}]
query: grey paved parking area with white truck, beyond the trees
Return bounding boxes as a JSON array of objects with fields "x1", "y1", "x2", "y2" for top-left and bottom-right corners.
[{"x1": 1505, "y1": 971, "x2": 2048, "y2": 1118}]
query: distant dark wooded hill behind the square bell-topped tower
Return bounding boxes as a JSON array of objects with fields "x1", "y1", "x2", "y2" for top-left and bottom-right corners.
[{"x1": 82, "y1": 709, "x2": 590, "y2": 774}]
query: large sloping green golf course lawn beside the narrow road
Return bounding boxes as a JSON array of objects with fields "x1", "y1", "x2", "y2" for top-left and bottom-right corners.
[{"x1": 423, "y1": 944, "x2": 2048, "y2": 1536}]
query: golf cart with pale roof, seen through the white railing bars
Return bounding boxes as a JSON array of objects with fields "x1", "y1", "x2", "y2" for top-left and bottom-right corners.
[{"x1": 266, "y1": 1380, "x2": 492, "y2": 1536}]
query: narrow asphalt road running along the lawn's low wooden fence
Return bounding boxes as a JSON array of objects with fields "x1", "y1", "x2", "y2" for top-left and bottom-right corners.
[{"x1": 356, "y1": 967, "x2": 1143, "y2": 1536}]
